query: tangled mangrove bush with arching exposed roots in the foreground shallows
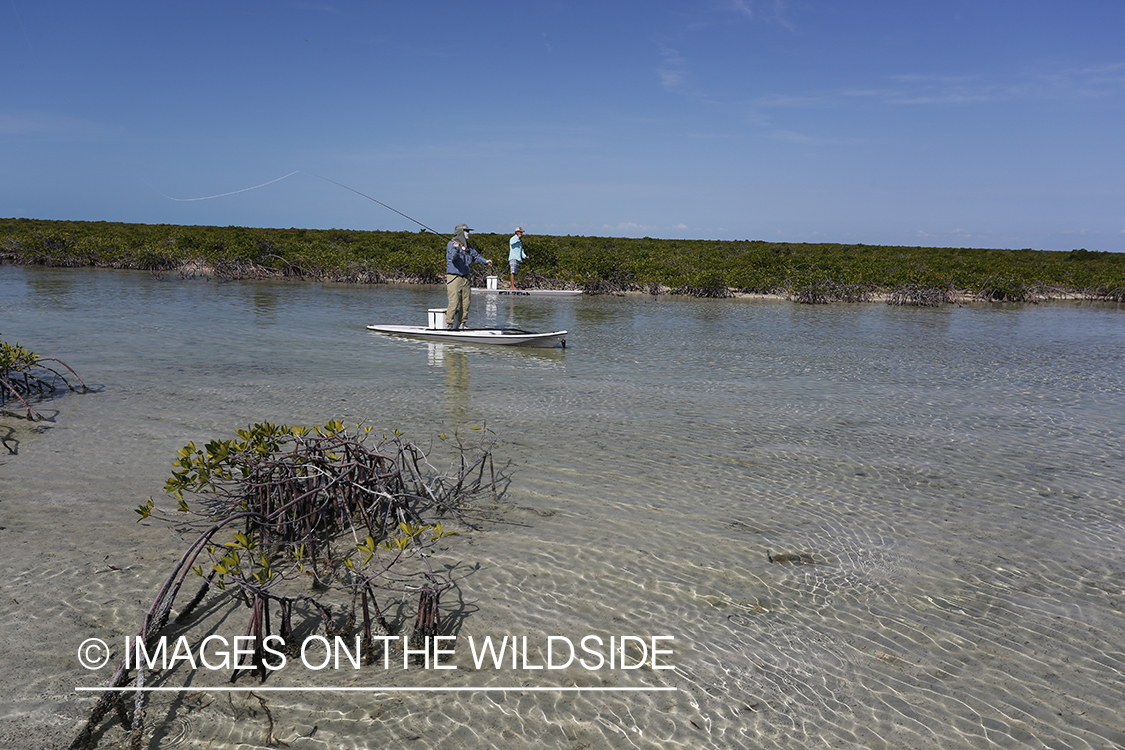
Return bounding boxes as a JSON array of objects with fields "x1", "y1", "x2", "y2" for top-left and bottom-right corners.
[{"x1": 71, "y1": 421, "x2": 496, "y2": 749}]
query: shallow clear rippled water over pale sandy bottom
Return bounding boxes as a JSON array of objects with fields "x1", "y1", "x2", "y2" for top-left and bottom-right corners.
[{"x1": 0, "y1": 265, "x2": 1125, "y2": 748}]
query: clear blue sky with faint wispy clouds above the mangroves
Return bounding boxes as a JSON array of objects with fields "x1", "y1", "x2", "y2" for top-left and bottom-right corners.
[{"x1": 0, "y1": 0, "x2": 1125, "y2": 251}]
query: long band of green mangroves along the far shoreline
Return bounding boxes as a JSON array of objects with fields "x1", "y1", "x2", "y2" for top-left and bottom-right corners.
[{"x1": 0, "y1": 219, "x2": 1125, "y2": 305}]
